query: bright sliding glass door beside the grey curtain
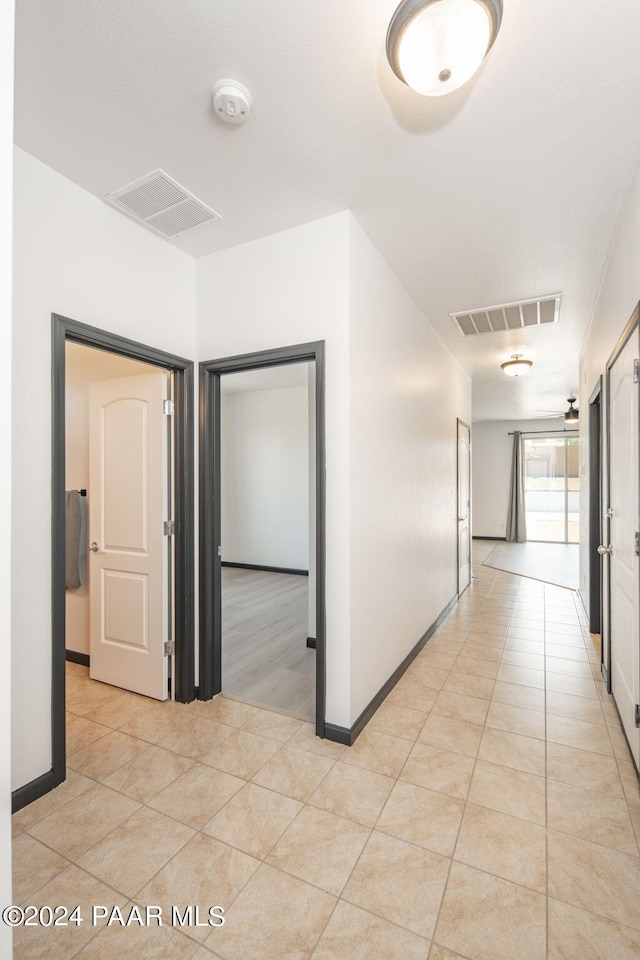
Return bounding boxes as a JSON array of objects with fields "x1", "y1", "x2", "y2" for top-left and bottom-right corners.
[{"x1": 523, "y1": 434, "x2": 580, "y2": 543}]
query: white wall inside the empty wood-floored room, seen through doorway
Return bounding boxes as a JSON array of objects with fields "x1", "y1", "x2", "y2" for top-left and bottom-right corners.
[{"x1": 220, "y1": 385, "x2": 309, "y2": 570}]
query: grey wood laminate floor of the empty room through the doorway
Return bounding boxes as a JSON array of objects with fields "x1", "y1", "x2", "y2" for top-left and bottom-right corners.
[{"x1": 222, "y1": 567, "x2": 316, "y2": 720}]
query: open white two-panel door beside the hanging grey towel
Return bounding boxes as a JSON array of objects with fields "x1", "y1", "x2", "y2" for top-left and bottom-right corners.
[{"x1": 88, "y1": 372, "x2": 169, "y2": 700}]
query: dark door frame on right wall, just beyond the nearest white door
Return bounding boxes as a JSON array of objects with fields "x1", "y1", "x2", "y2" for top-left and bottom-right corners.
[{"x1": 589, "y1": 377, "x2": 604, "y2": 640}]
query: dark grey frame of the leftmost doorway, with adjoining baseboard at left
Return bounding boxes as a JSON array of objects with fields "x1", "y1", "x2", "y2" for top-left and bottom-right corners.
[{"x1": 13, "y1": 313, "x2": 196, "y2": 810}]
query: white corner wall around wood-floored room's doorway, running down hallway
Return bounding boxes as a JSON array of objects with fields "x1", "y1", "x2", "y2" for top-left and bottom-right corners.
[{"x1": 197, "y1": 212, "x2": 471, "y2": 727}]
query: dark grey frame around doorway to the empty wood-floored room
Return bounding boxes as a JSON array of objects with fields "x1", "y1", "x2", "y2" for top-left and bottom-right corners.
[{"x1": 199, "y1": 341, "x2": 326, "y2": 737}]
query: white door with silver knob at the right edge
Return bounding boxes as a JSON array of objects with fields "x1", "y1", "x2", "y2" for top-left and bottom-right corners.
[{"x1": 609, "y1": 332, "x2": 640, "y2": 765}]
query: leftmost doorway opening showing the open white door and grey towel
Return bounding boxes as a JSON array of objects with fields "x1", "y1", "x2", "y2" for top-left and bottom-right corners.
[{"x1": 65, "y1": 342, "x2": 174, "y2": 709}]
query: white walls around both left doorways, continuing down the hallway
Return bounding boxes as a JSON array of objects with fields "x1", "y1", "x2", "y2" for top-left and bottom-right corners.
[{"x1": 12, "y1": 165, "x2": 484, "y2": 787}]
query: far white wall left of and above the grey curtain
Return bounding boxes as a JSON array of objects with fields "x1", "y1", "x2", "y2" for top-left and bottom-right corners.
[{"x1": 471, "y1": 417, "x2": 564, "y2": 537}]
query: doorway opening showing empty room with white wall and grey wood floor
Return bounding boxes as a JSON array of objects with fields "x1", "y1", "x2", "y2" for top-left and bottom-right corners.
[{"x1": 220, "y1": 363, "x2": 316, "y2": 720}]
